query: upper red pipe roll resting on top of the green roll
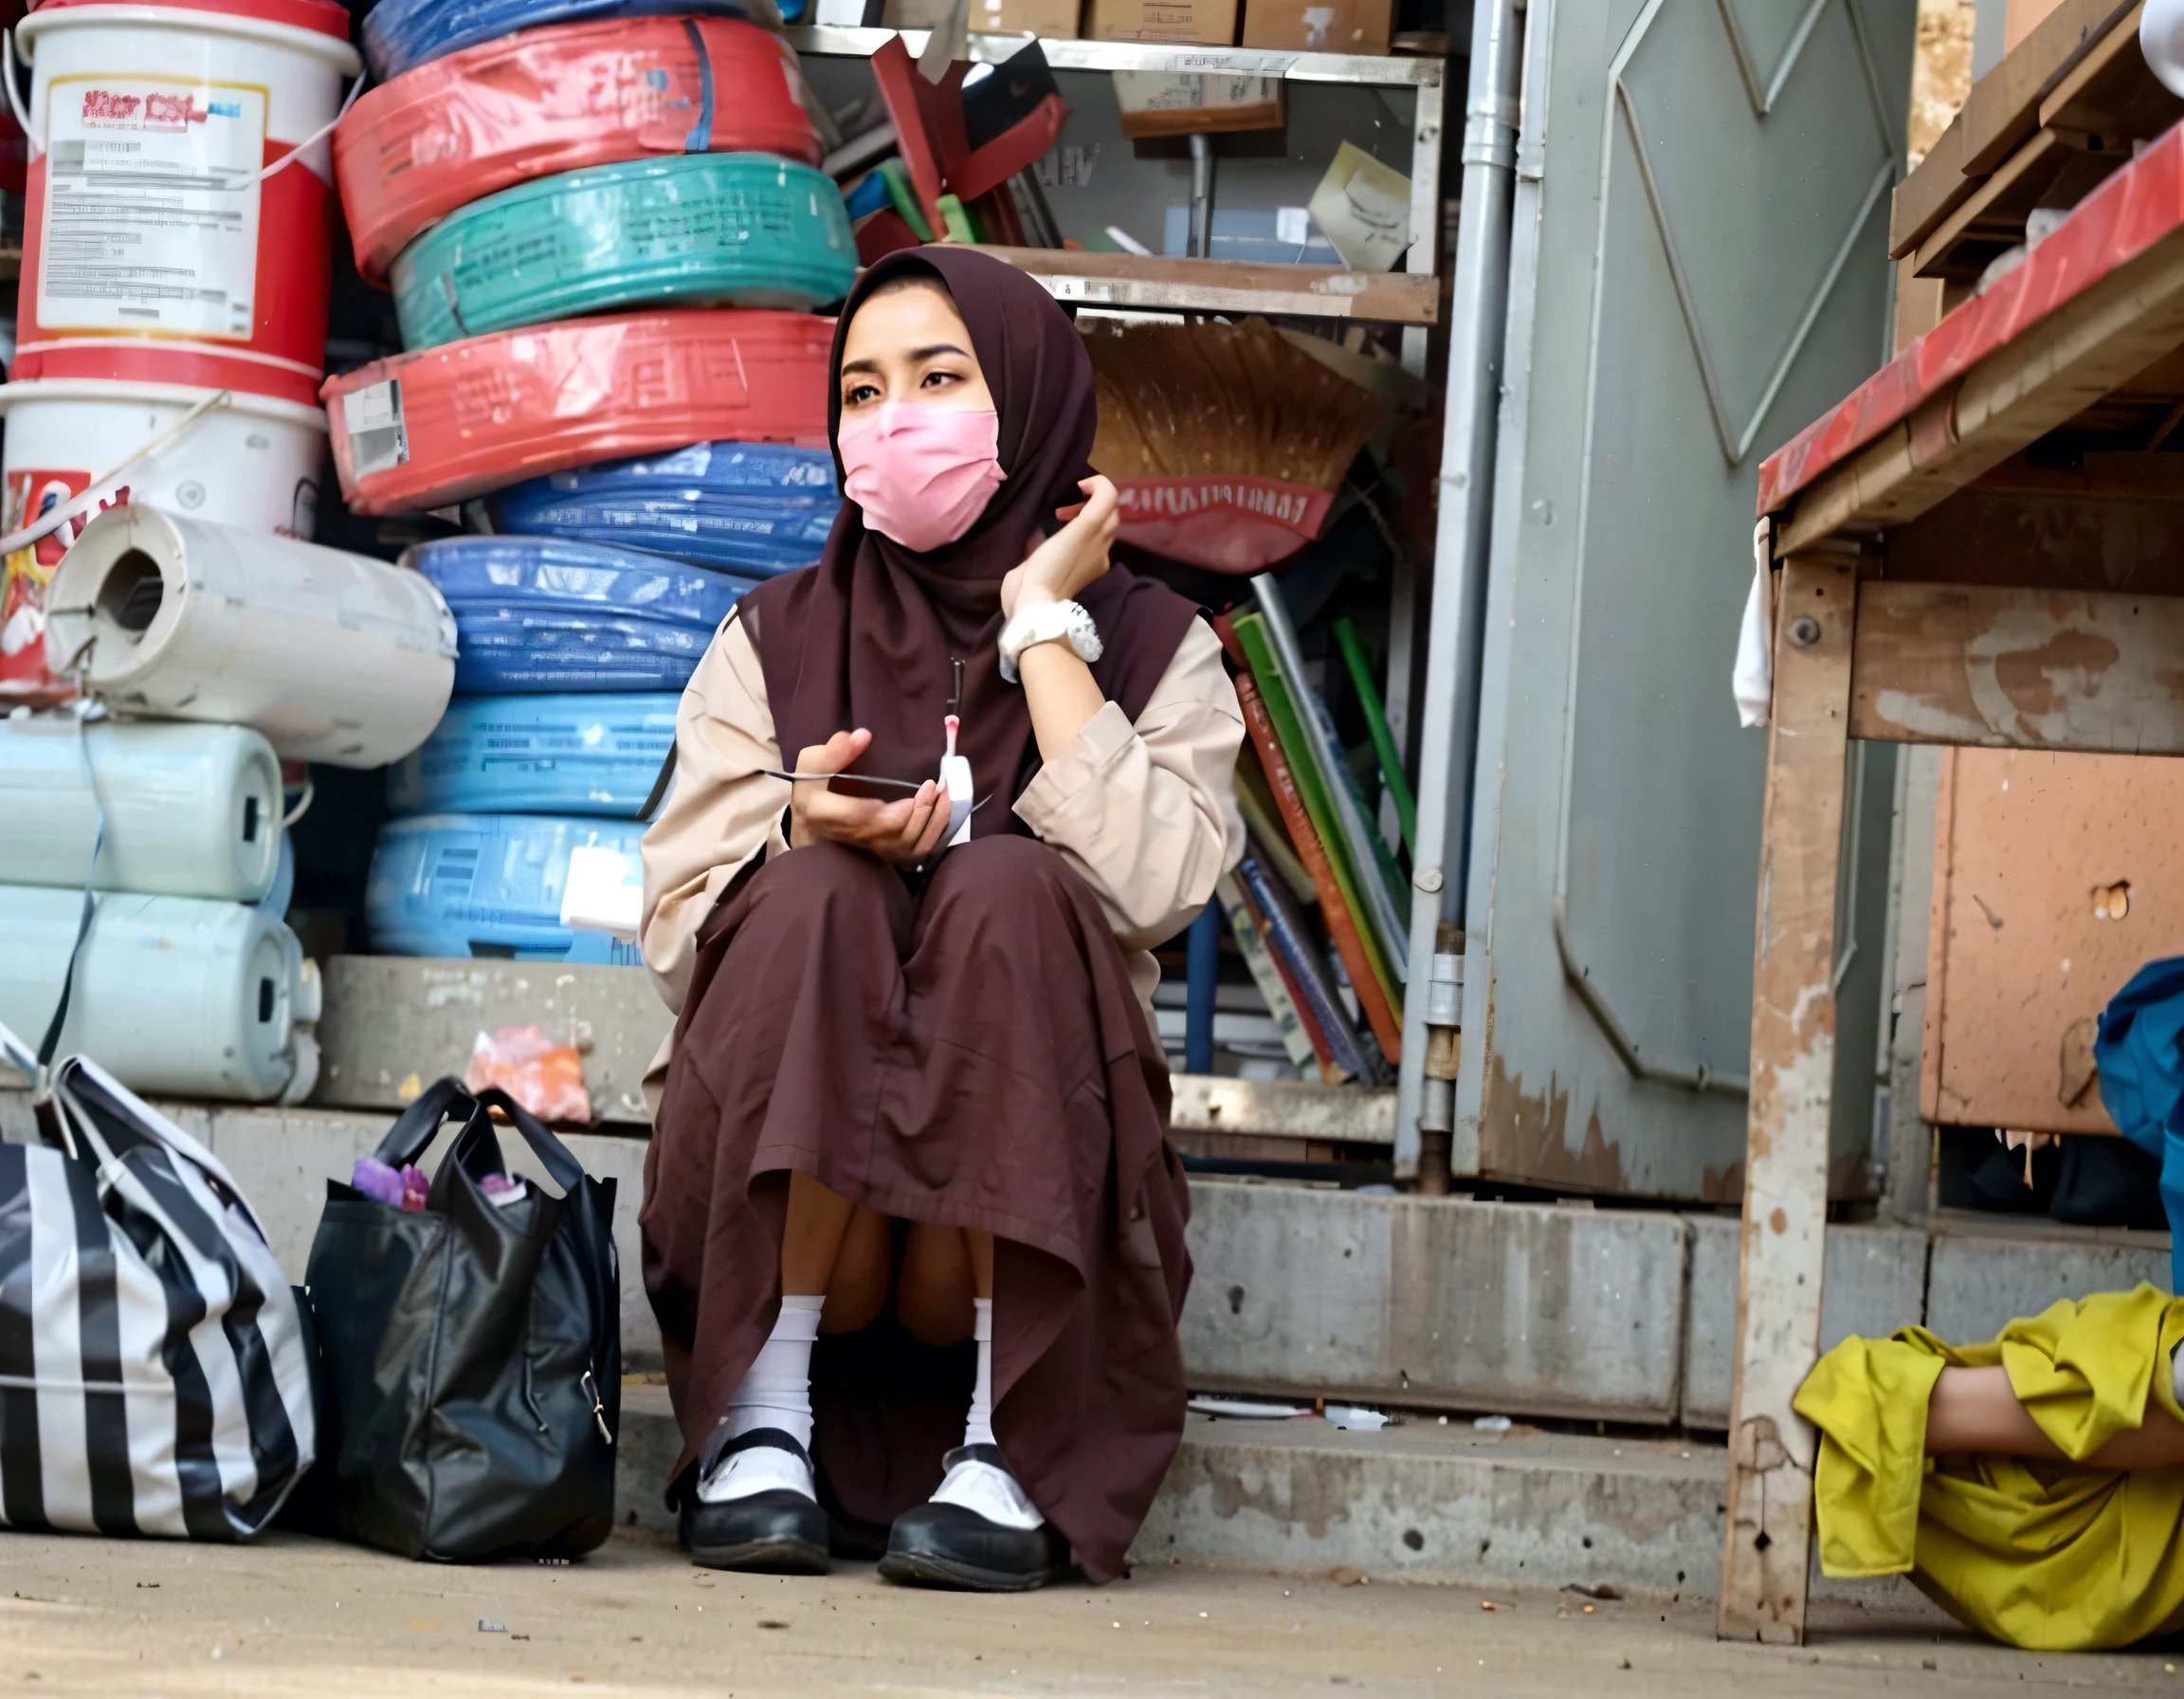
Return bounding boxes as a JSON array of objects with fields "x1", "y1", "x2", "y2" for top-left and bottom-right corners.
[{"x1": 335, "y1": 17, "x2": 824, "y2": 286}]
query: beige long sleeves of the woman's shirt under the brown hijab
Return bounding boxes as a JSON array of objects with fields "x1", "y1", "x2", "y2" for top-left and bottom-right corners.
[{"x1": 640, "y1": 613, "x2": 1243, "y2": 1087}]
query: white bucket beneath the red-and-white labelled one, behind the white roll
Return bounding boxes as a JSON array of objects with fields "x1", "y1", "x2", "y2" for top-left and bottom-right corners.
[{"x1": 0, "y1": 377, "x2": 325, "y2": 537}]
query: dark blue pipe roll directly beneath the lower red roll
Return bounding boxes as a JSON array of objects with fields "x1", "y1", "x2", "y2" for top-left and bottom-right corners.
[{"x1": 494, "y1": 444, "x2": 841, "y2": 578}]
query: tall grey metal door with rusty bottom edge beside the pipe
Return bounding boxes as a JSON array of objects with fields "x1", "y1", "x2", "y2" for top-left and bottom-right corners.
[{"x1": 1432, "y1": 0, "x2": 1913, "y2": 1203}]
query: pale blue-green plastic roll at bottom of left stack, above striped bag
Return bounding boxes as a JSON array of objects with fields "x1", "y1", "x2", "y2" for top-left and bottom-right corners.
[{"x1": 0, "y1": 885, "x2": 318, "y2": 1103}]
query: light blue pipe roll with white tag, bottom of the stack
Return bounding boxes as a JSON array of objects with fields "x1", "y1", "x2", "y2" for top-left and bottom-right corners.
[{"x1": 365, "y1": 814, "x2": 645, "y2": 967}]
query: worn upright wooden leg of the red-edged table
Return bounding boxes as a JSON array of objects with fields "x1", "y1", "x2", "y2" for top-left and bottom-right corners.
[{"x1": 1717, "y1": 555, "x2": 1859, "y2": 1644}]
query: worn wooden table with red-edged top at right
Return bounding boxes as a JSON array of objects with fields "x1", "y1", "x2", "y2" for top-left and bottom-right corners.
[{"x1": 1719, "y1": 112, "x2": 2184, "y2": 1640}]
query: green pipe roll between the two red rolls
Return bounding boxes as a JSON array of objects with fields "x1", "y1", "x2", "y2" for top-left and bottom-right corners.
[{"x1": 389, "y1": 153, "x2": 856, "y2": 347}]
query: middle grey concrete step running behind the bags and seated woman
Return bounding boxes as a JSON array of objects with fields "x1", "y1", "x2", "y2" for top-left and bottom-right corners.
[{"x1": 0, "y1": 1092, "x2": 2169, "y2": 1431}]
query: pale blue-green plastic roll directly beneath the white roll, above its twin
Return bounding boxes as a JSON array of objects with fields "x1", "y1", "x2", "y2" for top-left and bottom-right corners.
[{"x1": 0, "y1": 714, "x2": 282, "y2": 902}]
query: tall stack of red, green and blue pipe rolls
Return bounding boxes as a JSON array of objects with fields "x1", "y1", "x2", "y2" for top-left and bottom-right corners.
[{"x1": 325, "y1": 0, "x2": 856, "y2": 963}]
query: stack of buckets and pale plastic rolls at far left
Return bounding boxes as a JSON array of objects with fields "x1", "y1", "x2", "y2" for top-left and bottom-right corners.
[{"x1": 0, "y1": 0, "x2": 454, "y2": 1101}]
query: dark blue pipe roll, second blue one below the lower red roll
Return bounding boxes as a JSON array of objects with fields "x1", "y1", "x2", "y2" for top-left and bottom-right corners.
[{"x1": 402, "y1": 538, "x2": 755, "y2": 697}]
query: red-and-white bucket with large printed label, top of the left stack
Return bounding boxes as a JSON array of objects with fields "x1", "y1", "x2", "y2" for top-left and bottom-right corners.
[{"x1": 17, "y1": 0, "x2": 358, "y2": 402}]
